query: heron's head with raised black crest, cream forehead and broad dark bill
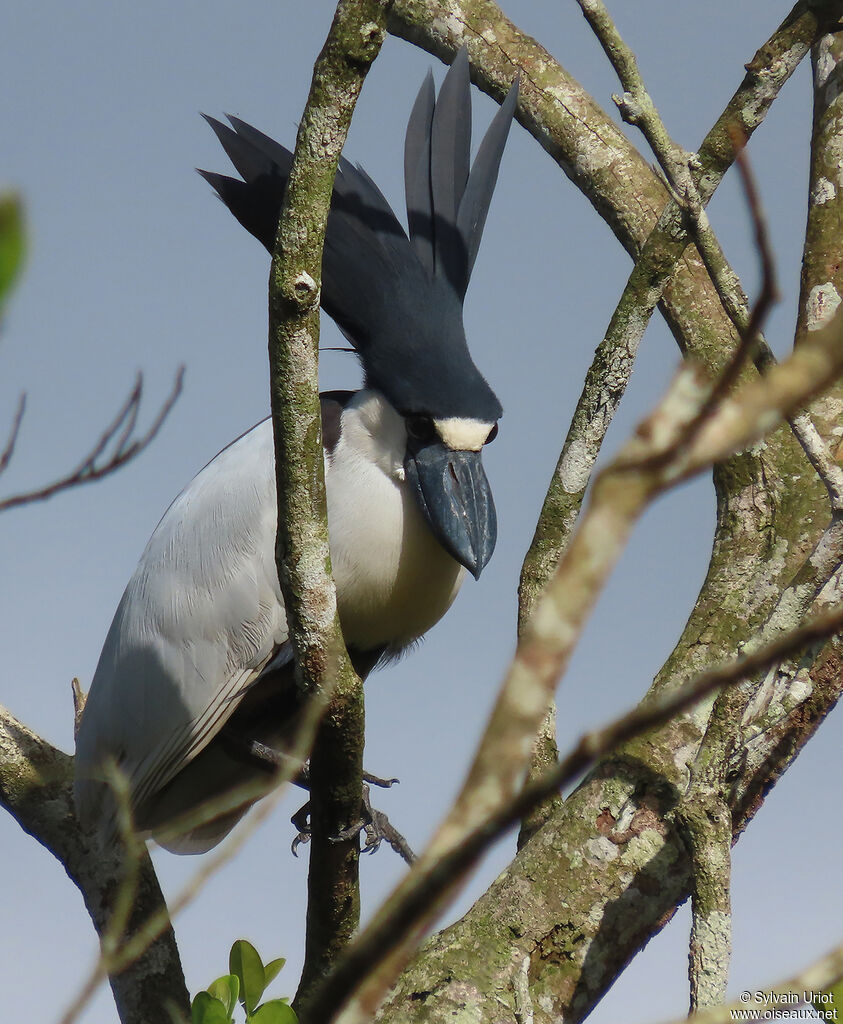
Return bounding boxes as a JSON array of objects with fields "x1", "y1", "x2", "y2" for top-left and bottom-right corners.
[{"x1": 202, "y1": 48, "x2": 518, "y2": 577}]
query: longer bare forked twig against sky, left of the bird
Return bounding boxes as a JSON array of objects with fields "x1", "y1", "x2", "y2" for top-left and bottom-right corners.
[{"x1": 0, "y1": 367, "x2": 184, "y2": 512}]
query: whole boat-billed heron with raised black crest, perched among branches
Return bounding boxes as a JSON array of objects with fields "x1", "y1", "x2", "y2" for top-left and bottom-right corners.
[{"x1": 76, "y1": 50, "x2": 517, "y2": 853}]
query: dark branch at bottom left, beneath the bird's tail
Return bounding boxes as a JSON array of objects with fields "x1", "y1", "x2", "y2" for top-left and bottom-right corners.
[{"x1": 0, "y1": 709, "x2": 189, "y2": 1024}]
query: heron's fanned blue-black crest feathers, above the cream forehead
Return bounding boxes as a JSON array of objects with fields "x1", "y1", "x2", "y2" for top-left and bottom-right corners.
[{"x1": 200, "y1": 47, "x2": 518, "y2": 422}]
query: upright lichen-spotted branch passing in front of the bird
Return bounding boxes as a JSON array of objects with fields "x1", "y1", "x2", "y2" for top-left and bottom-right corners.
[{"x1": 269, "y1": 0, "x2": 385, "y2": 1019}]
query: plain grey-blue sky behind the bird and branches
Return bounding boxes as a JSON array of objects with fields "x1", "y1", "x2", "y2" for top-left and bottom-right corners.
[{"x1": 0, "y1": 0, "x2": 843, "y2": 1024}]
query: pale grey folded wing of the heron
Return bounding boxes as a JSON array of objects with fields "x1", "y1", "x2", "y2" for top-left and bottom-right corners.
[{"x1": 76, "y1": 421, "x2": 287, "y2": 825}]
